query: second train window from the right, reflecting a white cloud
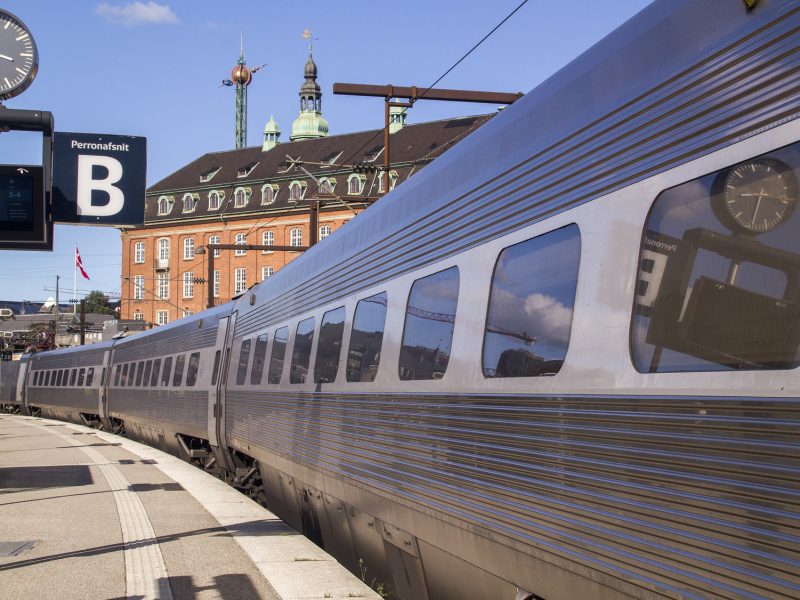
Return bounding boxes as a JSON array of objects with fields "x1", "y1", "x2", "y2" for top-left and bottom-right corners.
[{"x1": 483, "y1": 225, "x2": 581, "y2": 377}]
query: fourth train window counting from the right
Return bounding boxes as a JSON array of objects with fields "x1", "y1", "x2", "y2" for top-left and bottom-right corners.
[{"x1": 346, "y1": 292, "x2": 386, "y2": 381}]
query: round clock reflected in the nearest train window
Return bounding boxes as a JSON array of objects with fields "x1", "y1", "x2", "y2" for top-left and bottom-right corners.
[{"x1": 712, "y1": 158, "x2": 799, "y2": 235}]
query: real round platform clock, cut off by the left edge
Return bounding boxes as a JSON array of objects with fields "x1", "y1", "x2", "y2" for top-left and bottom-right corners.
[{"x1": 0, "y1": 9, "x2": 39, "y2": 100}]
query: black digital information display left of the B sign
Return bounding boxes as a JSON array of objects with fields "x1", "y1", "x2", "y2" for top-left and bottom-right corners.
[{"x1": 0, "y1": 165, "x2": 53, "y2": 250}]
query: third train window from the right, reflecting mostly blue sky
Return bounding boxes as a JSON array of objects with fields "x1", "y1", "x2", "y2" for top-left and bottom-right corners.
[{"x1": 399, "y1": 267, "x2": 459, "y2": 380}]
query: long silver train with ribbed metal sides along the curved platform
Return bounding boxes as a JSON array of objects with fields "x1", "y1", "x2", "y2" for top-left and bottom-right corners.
[{"x1": 0, "y1": 0, "x2": 800, "y2": 600}]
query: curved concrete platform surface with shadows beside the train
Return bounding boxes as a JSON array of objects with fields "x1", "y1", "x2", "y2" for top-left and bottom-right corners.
[{"x1": 0, "y1": 415, "x2": 379, "y2": 600}]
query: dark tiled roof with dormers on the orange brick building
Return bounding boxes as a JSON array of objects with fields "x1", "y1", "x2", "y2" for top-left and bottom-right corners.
[{"x1": 145, "y1": 114, "x2": 493, "y2": 225}]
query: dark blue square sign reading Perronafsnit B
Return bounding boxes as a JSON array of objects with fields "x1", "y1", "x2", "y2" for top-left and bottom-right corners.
[{"x1": 53, "y1": 132, "x2": 147, "y2": 225}]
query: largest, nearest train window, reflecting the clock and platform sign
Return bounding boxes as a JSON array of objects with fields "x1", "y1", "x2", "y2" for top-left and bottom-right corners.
[{"x1": 631, "y1": 144, "x2": 800, "y2": 373}]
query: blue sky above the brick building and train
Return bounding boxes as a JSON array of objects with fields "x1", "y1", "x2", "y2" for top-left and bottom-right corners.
[{"x1": 0, "y1": 0, "x2": 649, "y2": 308}]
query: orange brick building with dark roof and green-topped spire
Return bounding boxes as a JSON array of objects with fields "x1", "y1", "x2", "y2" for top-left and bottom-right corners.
[{"x1": 120, "y1": 54, "x2": 492, "y2": 325}]
